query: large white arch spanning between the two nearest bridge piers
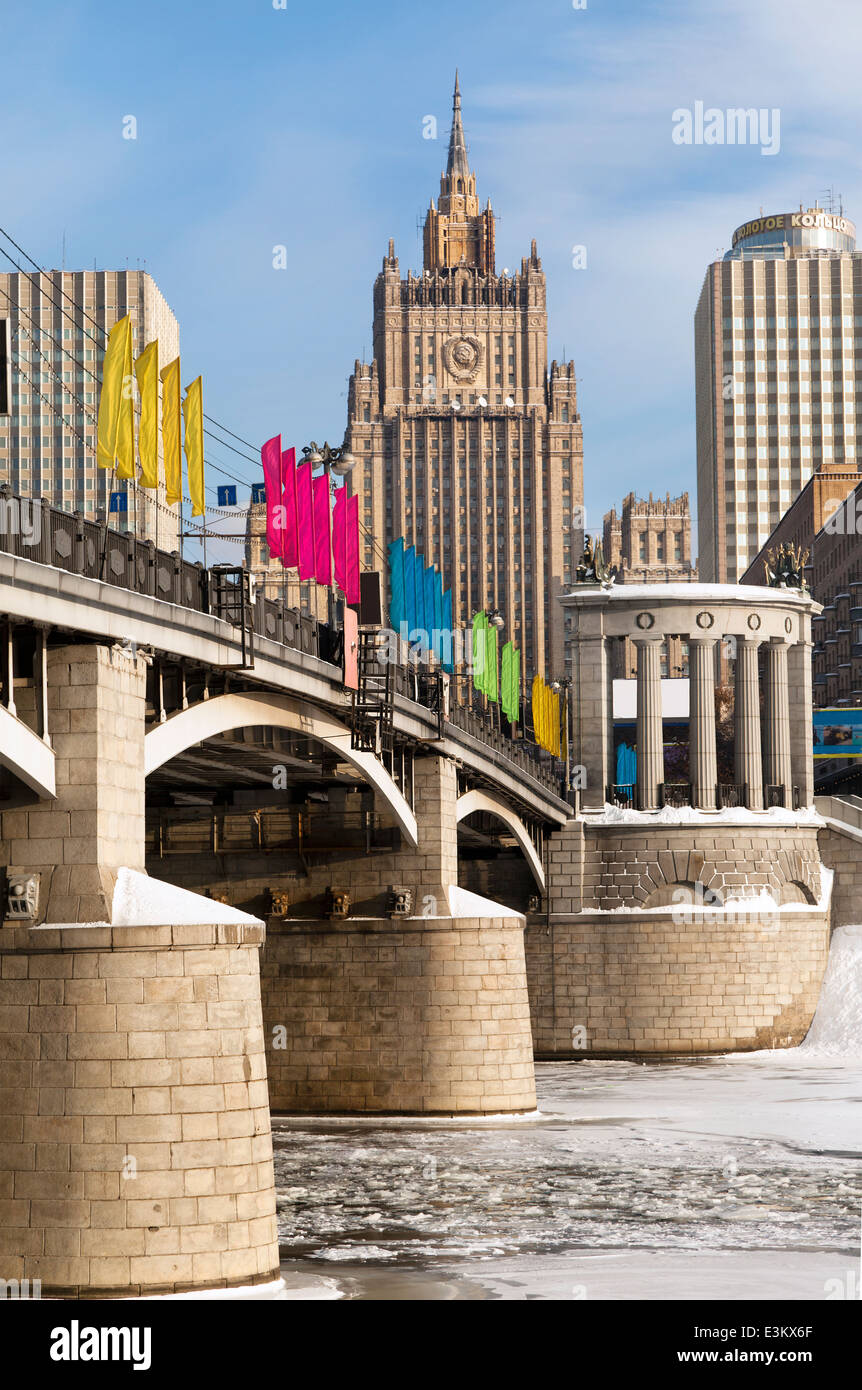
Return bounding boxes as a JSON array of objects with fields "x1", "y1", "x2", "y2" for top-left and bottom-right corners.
[{"x1": 145, "y1": 691, "x2": 418, "y2": 848}]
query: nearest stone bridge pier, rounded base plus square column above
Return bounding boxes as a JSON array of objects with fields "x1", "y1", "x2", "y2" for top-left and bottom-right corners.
[{"x1": 0, "y1": 644, "x2": 278, "y2": 1298}]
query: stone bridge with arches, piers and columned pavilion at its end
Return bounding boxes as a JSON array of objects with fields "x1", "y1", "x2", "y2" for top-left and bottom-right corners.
[{"x1": 0, "y1": 509, "x2": 862, "y2": 1297}]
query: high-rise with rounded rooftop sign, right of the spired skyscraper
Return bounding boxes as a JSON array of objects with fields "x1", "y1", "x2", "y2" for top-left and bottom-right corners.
[{"x1": 695, "y1": 207, "x2": 862, "y2": 582}]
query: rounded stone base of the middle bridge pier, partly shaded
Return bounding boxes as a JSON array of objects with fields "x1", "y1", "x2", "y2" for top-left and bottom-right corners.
[{"x1": 261, "y1": 917, "x2": 535, "y2": 1115}]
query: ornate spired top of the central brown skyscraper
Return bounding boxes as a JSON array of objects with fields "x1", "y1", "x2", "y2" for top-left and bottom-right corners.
[{"x1": 424, "y1": 72, "x2": 494, "y2": 275}]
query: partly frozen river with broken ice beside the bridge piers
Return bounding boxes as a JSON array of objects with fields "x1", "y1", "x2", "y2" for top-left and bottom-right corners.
[{"x1": 275, "y1": 940, "x2": 862, "y2": 1298}]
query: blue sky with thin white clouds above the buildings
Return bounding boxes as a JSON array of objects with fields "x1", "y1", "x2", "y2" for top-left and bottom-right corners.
[{"x1": 6, "y1": 0, "x2": 862, "y2": 558}]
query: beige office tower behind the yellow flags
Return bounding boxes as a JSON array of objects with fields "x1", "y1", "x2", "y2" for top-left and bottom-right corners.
[{"x1": 0, "y1": 270, "x2": 179, "y2": 550}]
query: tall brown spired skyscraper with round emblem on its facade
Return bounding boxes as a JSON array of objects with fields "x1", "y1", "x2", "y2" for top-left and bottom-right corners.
[{"x1": 348, "y1": 76, "x2": 583, "y2": 676}]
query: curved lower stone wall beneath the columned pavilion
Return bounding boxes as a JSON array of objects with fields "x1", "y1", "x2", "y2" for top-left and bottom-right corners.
[{"x1": 526, "y1": 908, "x2": 829, "y2": 1058}]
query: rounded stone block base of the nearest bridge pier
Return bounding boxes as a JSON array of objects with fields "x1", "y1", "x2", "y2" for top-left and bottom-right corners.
[{"x1": 0, "y1": 924, "x2": 278, "y2": 1298}]
